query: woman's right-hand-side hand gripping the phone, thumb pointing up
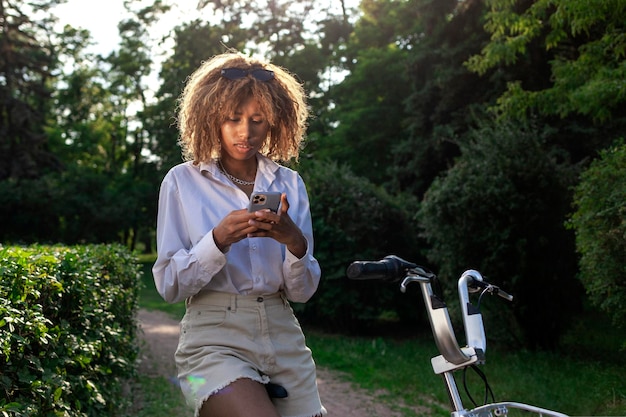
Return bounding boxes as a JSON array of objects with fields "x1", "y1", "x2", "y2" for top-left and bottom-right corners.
[{"x1": 248, "y1": 193, "x2": 307, "y2": 258}]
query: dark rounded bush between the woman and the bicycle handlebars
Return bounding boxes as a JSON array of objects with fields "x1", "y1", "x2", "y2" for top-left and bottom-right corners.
[{"x1": 297, "y1": 161, "x2": 423, "y2": 332}]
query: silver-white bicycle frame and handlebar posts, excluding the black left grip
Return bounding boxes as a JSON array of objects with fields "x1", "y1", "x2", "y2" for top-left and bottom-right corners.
[{"x1": 400, "y1": 270, "x2": 567, "y2": 417}]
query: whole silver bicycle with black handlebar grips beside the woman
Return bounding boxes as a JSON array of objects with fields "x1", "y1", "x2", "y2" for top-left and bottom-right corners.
[{"x1": 346, "y1": 255, "x2": 568, "y2": 417}]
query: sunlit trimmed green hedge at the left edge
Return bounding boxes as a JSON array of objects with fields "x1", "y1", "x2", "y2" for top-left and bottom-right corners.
[{"x1": 0, "y1": 245, "x2": 140, "y2": 416}]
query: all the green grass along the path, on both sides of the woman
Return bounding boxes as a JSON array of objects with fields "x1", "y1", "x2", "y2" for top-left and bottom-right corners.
[{"x1": 129, "y1": 256, "x2": 626, "y2": 417}]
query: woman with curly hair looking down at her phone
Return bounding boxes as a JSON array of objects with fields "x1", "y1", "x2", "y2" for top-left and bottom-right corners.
[{"x1": 153, "y1": 53, "x2": 326, "y2": 417}]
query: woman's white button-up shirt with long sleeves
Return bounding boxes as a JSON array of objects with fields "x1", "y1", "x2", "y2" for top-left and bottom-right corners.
[{"x1": 152, "y1": 154, "x2": 321, "y2": 303}]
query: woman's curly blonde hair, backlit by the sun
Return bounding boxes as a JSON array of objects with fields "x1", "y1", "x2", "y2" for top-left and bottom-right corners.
[{"x1": 178, "y1": 52, "x2": 309, "y2": 164}]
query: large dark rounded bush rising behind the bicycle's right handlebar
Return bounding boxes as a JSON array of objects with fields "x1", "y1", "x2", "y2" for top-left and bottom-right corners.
[{"x1": 418, "y1": 123, "x2": 581, "y2": 348}]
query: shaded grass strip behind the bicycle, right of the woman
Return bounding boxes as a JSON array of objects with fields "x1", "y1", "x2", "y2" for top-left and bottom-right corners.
[{"x1": 306, "y1": 331, "x2": 626, "y2": 416}]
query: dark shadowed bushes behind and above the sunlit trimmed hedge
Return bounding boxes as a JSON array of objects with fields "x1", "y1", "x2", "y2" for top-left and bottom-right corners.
[{"x1": 0, "y1": 167, "x2": 158, "y2": 248}]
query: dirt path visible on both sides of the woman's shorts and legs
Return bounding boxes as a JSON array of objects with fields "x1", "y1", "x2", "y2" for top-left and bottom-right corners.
[{"x1": 138, "y1": 310, "x2": 426, "y2": 417}]
